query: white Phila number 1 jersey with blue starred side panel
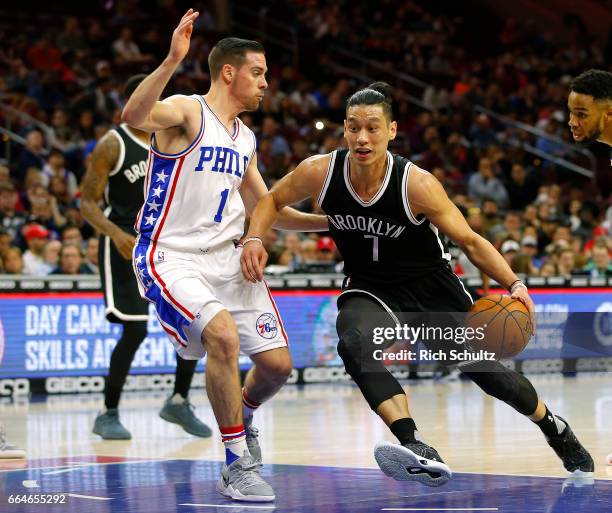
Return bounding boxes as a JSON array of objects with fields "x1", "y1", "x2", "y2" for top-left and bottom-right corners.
[{"x1": 135, "y1": 95, "x2": 255, "y2": 253}]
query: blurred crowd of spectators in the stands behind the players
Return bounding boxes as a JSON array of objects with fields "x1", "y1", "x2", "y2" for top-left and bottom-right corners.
[{"x1": 0, "y1": 0, "x2": 612, "y2": 277}]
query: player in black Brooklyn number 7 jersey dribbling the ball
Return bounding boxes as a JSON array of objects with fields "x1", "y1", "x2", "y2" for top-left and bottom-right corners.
[{"x1": 241, "y1": 83, "x2": 594, "y2": 486}]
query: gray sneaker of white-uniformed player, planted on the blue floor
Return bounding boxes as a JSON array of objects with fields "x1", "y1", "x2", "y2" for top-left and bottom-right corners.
[{"x1": 217, "y1": 451, "x2": 276, "y2": 502}]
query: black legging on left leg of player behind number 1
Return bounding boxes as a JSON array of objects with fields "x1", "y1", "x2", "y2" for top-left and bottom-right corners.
[{"x1": 104, "y1": 321, "x2": 147, "y2": 410}]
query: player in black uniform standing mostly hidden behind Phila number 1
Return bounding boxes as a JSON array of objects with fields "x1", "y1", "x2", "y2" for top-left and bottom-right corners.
[{"x1": 81, "y1": 75, "x2": 212, "y2": 440}]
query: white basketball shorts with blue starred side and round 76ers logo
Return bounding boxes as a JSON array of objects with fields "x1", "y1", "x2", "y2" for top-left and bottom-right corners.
[{"x1": 133, "y1": 238, "x2": 289, "y2": 360}]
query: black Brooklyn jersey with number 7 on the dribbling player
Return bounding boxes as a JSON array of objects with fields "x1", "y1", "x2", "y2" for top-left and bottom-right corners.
[{"x1": 318, "y1": 150, "x2": 450, "y2": 284}]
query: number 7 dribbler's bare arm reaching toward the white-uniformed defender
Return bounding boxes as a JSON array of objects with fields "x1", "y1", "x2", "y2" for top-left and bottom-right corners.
[{"x1": 240, "y1": 155, "x2": 329, "y2": 283}]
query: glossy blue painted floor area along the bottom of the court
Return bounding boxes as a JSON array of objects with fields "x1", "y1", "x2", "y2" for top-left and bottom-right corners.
[{"x1": 0, "y1": 460, "x2": 612, "y2": 513}]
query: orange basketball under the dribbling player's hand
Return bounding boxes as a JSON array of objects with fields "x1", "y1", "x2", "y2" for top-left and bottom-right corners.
[{"x1": 466, "y1": 294, "x2": 533, "y2": 360}]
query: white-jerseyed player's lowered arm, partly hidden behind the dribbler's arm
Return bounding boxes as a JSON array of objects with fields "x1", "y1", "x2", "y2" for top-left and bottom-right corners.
[{"x1": 240, "y1": 155, "x2": 329, "y2": 232}]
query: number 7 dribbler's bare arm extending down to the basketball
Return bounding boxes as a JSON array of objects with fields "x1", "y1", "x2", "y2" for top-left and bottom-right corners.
[{"x1": 408, "y1": 166, "x2": 535, "y2": 330}]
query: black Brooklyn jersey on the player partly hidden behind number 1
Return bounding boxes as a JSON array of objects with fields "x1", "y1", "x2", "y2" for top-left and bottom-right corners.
[{"x1": 104, "y1": 124, "x2": 149, "y2": 225}]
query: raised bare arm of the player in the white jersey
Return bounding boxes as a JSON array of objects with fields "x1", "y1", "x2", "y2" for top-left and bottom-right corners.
[{"x1": 121, "y1": 9, "x2": 199, "y2": 132}]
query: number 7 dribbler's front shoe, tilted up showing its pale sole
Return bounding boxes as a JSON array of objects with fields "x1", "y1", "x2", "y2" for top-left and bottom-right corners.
[{"x1": 374, "y1": 441, "x2": 453, "y2": 486}]
